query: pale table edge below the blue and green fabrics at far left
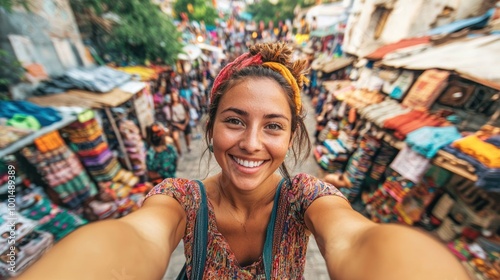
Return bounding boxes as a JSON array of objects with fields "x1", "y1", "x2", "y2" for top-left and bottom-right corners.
[{"x1": 0, "y1": 114, "x2": 77, "y2": 158}]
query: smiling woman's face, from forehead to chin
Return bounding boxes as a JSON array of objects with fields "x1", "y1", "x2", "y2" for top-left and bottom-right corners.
[{"x1": 212, "y1": 78, "x2": 292, "y2": 190}]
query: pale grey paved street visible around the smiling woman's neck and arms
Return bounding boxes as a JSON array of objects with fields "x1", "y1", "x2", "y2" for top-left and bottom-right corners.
[{"x1": 163, "y1": 97, "x2": 329, "y2": 280}]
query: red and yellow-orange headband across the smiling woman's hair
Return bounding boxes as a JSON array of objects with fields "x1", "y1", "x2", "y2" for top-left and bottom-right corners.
[{"x1": 210, "y1": 53, "x2": 305, "y2": 114}]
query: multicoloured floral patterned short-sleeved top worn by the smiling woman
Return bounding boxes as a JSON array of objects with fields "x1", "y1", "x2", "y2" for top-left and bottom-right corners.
[{"x1": 146, "y1": 173, "x2": 345, "y2": 279}]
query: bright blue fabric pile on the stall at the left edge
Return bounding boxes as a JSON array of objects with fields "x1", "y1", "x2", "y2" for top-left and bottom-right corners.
[{"x1": 0, "y1": 101, "x2": 62, "y2": 127}]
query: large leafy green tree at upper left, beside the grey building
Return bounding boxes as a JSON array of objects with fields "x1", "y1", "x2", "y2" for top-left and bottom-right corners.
[{"x1": 69, "y1": 0, "x2": 182, "y2": 64}]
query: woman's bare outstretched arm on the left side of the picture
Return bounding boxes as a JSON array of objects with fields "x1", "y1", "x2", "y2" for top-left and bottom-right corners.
[{"x1": 18, "y1": 195, "x2": 185, "y2": 280}]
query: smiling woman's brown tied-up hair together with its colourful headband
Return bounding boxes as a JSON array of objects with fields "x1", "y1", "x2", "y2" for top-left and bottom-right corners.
[{"x1": 205, "y1": 42, "x2": 311, "y2": 178}]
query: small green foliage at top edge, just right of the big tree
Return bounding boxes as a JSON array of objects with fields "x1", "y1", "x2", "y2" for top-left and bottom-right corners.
[{"x1": 174, "y1": 0, "x2": 218, "y2": 25}]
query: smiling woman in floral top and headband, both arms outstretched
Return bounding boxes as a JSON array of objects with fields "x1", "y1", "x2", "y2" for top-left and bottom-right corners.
[{"x1": 20, "y1": 43, "x2": 468, "y2": 279}]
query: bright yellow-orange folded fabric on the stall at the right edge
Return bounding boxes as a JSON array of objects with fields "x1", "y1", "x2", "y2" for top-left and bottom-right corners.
[{"x1": 452, "y1": 135, "x2": 500, "y2": 168}]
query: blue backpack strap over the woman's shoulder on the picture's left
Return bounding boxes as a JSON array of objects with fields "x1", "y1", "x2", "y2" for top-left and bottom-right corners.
[{"x1": 191, "y1": 180, "x2": 208, "y2": 280}]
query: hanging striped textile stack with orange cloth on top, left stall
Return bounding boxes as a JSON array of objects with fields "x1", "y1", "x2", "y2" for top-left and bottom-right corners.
[{"x1": 21, "y1": 131, "x2": 97, "y2": 209}]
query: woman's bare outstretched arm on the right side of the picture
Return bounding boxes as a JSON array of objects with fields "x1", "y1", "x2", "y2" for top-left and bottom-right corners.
[{"x1": 306, "y1": 196, "x2": 470, "y2": 280}]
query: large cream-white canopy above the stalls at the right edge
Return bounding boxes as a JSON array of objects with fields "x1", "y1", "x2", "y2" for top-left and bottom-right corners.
[{"x1": 381, "y1": 34, "x2": 500, "y2": 89}]
